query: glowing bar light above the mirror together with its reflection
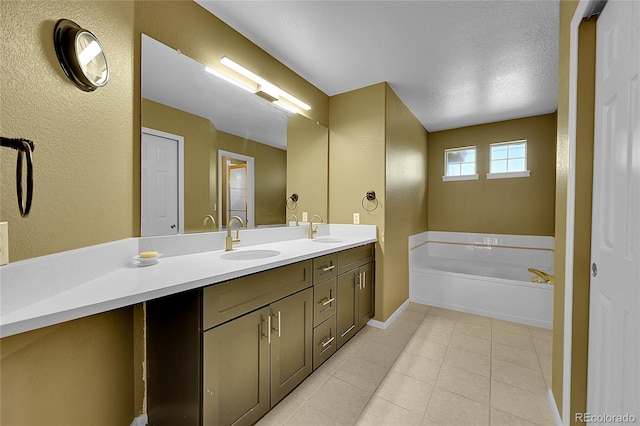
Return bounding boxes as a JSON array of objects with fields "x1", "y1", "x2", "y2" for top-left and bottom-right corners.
[{"x1": 205, "y1": 56, "x2": 311, "y2": 114}]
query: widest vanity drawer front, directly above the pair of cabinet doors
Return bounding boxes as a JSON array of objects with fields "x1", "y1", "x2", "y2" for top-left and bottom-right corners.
[{"x1": 202, "y1": 260, "x2": 312, "y2": 330}]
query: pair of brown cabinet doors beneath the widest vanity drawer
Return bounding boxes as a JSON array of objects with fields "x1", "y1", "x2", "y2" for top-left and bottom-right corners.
[{"x1": 202, "y1": 288, "x2": 312, "y2": 425}]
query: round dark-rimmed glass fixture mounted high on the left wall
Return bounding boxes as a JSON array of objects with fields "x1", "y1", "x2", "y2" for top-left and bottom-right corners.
[{"x1": 53, "y1": 19, "x2": 109, "y2": 92}]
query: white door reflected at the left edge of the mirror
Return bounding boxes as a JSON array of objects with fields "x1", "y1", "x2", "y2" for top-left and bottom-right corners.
[{"x1": 140, "y1": 132, "x2": 179, "y2": 236}]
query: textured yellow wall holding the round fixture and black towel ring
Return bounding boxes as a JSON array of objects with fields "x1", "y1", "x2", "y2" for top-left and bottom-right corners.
[{"x1": 0, "y1": 1, "x2": 134, "y2": 261}]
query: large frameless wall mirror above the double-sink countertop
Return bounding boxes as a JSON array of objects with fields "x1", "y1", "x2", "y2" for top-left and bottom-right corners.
[{"x1": 141, "y1": 35, "x2": 328, "y2": 236}]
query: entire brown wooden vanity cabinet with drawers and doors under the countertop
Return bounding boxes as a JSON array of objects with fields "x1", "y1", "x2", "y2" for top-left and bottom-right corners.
[{"x1": 146, "y1": 244, "x2": 374, "y2": 426}]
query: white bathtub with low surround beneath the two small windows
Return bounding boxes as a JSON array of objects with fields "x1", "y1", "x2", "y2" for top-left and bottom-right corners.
[{"x1": 409, "y1": 231, "x2": 554, "y2": 329}]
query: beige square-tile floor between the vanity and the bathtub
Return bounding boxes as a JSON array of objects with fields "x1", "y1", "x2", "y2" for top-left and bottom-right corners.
[{"x1": 258, "y1": 303, "x2": 554, "y2": 426}]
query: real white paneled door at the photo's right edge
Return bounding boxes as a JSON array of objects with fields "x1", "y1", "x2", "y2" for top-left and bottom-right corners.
[{"x1": 587, "y1": 0, "x2": 640, "y2": 423}]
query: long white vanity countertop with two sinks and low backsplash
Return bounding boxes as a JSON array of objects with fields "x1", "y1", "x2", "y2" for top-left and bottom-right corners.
[{"x1": 0, "y1": 225, "x2": 376, "y2": 337}]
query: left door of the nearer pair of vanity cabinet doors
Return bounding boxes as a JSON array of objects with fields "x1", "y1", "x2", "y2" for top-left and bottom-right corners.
[{"x1": 202, "y1": 308, "x2": 270, "y2": 426}]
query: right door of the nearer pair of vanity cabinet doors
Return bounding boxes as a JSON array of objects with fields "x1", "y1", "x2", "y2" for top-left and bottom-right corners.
[{"x1": 271, "y1": 288, "x2": 313, "y2": 406}]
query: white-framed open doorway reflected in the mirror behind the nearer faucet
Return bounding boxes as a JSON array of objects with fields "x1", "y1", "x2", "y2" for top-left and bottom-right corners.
[{"x1": 218, "y1": 150, "x2": 255, "y2": 229}]
